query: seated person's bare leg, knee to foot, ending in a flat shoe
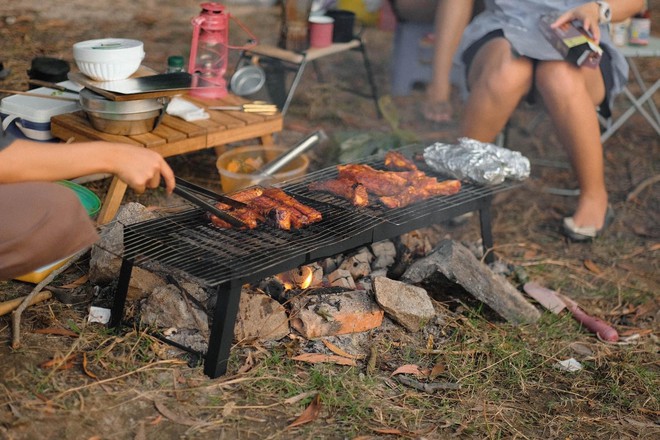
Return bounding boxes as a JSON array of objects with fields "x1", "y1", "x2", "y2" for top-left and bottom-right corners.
[{"x1": 536, "y1": 61, "x2": 607, "y2": 229}]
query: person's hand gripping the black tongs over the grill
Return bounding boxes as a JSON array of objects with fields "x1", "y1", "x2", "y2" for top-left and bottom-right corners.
[{"x1": 115, "y1": 145, "x2": 175, "y2": 194}]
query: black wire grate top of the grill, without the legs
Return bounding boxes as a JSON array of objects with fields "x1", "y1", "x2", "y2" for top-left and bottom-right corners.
[{"x1": 124, "y1": 144, "x2": 512, "y2": 286}]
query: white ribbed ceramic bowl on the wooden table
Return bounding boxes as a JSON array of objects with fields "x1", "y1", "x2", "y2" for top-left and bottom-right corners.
[{"x1": 73, "y1": 38, "x2": 144, "y2": 81}]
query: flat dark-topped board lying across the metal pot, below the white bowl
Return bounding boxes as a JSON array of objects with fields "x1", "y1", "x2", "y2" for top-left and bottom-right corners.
[{"x1": 68, "y1": 67, "x2": 192, "y2": 101}]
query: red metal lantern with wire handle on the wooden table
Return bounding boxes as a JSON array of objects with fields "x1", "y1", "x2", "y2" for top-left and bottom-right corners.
[{"x1": 188, "y1": 2, "x2": 257, "y2": 98}]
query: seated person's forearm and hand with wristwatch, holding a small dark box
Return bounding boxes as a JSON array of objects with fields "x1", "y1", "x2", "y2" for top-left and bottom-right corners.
[{"x1": 552, "y1": 0, "x2": 644, "y2": 42}]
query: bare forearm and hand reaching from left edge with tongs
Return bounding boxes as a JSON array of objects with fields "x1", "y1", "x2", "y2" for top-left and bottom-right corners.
[{"x1": 0, "y1": 139, "x2": 175, "y2": 194}]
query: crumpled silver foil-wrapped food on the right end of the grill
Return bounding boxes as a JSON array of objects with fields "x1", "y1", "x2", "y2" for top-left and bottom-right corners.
[{"x1": 424, "y1": 138, "x2": 530, "y2": 185}]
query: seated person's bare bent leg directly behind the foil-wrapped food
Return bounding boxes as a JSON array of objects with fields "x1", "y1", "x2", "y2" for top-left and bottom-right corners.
[{"x1": 460, "y1": 38, "x2": 533, "y2": 142}]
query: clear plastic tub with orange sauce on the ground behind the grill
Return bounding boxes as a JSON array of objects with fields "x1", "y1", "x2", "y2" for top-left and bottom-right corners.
[{"x1": 216, "y1": 145, "x2": 309, "y2": 193}]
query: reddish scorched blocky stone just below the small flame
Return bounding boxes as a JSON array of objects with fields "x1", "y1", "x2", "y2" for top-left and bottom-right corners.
[{"x1": 290, "y1": 290, "x2": 384, "y2": 339}]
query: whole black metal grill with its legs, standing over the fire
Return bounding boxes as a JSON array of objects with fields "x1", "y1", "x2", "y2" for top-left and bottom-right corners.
[{"x1": 110, "y1": 146, "x2": 516, "y2": 378}]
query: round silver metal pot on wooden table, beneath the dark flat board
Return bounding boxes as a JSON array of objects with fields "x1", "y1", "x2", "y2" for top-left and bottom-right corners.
[{"x1": 80, "y1": 88, "x2": 165, "y2": 136}]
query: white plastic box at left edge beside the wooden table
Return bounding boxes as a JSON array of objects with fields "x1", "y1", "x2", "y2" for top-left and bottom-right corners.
[{"x1": 0, "y1": 81, "x2": 82, "y2": 141}]
